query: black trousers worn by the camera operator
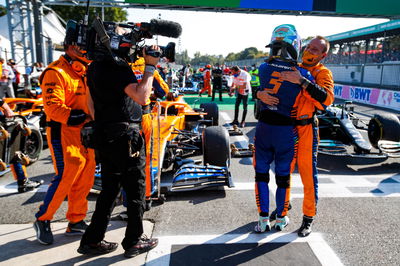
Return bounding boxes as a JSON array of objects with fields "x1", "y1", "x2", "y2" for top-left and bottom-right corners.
[{"x1": 81, "y1": 129, "x2": 146, "y2": 249}]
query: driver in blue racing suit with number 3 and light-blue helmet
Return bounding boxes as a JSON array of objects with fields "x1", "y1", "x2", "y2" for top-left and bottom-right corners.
[{"x1": 254, "y1": 24, "x2": 313, "y2": 233}]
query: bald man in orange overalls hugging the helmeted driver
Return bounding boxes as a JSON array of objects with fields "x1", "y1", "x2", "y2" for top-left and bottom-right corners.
[{"x1": 257, "y1": 36, "x2": 334, "y2": 237}]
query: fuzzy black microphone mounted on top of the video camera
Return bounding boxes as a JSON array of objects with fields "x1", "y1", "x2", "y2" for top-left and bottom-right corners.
[{"x1": 140, "y1": 19, "x2": 182, "y2": 38}]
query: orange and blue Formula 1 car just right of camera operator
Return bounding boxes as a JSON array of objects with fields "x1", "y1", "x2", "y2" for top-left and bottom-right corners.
[{"x1": 94, "y1": 92, "x2": 233, "y2": 201}]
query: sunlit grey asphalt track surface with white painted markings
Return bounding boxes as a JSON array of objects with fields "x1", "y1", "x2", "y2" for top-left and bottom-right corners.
[{"x1": 0, "y1": 93, "x2": 400, "y2": 265}]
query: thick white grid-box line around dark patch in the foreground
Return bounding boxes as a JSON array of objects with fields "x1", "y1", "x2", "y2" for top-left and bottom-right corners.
[{"x1": 146, "y1": 232, "x2": 343, "y2": 266}]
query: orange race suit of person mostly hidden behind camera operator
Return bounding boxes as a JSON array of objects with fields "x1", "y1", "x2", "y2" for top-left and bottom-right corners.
[{"x1": 131, "y1": 57, "x2": 169, "y2": 198}]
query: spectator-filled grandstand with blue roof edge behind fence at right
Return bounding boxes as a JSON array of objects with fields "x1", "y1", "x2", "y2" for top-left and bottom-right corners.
[{"x1": 324, "y1": 20, "x2": 400, "y2": 90}]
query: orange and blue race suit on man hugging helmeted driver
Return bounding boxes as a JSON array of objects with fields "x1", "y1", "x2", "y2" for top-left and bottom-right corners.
[{"x1": 292, "y1": 64, "x2": 334, "y2": 217}]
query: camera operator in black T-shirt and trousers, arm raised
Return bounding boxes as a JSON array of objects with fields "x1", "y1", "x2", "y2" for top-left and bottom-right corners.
[{"x1": 78, "y1": 46, "x2": 160, "y2": 258}]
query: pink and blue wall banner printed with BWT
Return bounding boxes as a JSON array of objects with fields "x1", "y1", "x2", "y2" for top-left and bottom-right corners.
[{"x1": 334, "y1": 84, "x2": 400, "y2": 111}]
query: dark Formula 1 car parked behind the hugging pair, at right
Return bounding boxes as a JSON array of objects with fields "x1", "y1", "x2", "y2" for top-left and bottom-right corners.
[{"x1": 318, "y1": 102, "x2": 400, "y2": 163}]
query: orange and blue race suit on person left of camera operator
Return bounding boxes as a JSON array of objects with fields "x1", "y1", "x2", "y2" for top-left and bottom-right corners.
[{"x1": 36, "y1": 55, "x2": 96, "y2": 223}]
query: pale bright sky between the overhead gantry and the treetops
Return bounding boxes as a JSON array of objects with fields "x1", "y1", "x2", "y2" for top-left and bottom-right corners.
[{"x1": 128, "y1": 8, "x2": 388, "y2": 57}]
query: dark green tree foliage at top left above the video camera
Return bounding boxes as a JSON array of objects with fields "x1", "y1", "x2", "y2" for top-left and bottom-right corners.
[{"x1": 52, "y1": 6, "x2": 128, "y2": 23}]
